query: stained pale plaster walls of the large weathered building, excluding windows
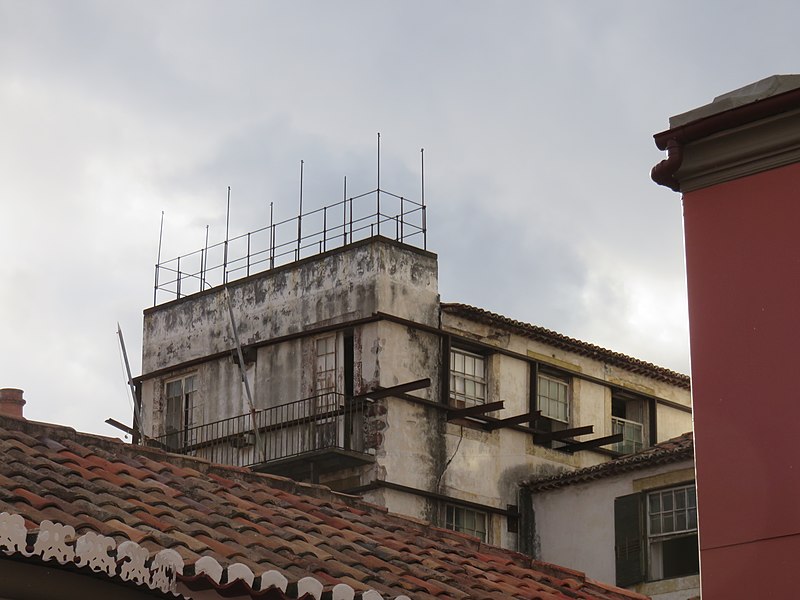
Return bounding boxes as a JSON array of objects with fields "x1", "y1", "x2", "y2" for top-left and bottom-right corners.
[{"x1": 142, "y1": 238, "x2": 691, "y2": 564}]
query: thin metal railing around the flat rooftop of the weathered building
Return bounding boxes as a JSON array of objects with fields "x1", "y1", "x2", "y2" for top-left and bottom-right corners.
[{"x1": 153, "y1": 188, "x2": 427, "y2": 306}]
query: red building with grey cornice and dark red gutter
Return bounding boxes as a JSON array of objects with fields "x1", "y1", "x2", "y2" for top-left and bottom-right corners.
[{"x1": 653, "y1": 75, "x2": 800, "y2": 600}]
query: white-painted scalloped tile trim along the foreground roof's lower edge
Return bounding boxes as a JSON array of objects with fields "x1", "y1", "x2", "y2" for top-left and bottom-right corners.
[{"x1": 0, "y1": 512, "x2": 411, "y2": 600}]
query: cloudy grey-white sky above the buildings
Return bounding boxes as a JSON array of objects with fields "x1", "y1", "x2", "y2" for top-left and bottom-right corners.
[{"x1": 0, "y1": 0, "x2": 800, "y2": 436}]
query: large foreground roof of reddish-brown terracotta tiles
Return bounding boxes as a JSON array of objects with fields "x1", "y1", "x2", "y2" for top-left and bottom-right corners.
[{"x1": 0, "y1": 416, "x2": 644, "y2": 600}]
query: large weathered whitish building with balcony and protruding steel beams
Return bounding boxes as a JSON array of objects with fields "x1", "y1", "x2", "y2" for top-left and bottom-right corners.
[{"x1": 137, "y1": 224, "x2": 691, "y2": 548}]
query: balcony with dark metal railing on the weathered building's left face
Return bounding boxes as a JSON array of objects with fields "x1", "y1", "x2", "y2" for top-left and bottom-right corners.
[{"x1": 150, "y1": 393, "x2": 374, "y2": 479}]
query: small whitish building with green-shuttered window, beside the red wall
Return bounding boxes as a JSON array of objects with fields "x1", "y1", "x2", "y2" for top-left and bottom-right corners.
[{"x1": 520, "y1": 433, "x2": 700, "y2": 600}]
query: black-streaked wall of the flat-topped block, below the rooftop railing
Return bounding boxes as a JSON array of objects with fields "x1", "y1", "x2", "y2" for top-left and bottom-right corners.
[{"x1": 142, "y1": 238, "x2": 439, "y2": 435}]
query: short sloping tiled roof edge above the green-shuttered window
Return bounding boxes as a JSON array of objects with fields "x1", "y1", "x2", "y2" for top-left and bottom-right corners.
[{"x1": 524, "y1": 432, "x2": 694, "y2": 492}]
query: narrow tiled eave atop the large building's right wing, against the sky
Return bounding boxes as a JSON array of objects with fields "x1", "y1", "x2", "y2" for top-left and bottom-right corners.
[{"x1": 442, "y1": 302, "x2": 689, "y2": 390}]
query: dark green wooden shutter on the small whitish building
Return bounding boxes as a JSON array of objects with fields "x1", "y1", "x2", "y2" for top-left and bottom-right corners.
[{"x1": 614, "y1": 494, "x2": 644, "y2": 587}]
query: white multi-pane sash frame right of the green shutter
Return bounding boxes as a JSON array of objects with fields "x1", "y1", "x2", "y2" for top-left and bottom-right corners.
[{"x1": 645, "y1": 483, "x2": 697, "y2": 581}]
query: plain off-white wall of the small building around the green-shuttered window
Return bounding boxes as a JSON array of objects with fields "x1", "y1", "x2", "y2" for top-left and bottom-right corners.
[{"x1": 532, "y1": 461, "x2": 700, "y2": 600}]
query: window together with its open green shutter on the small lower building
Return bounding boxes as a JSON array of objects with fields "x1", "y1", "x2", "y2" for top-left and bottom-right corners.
[{"x1": 614, "y1": 484, "x2": 700, "y2": 587}]
